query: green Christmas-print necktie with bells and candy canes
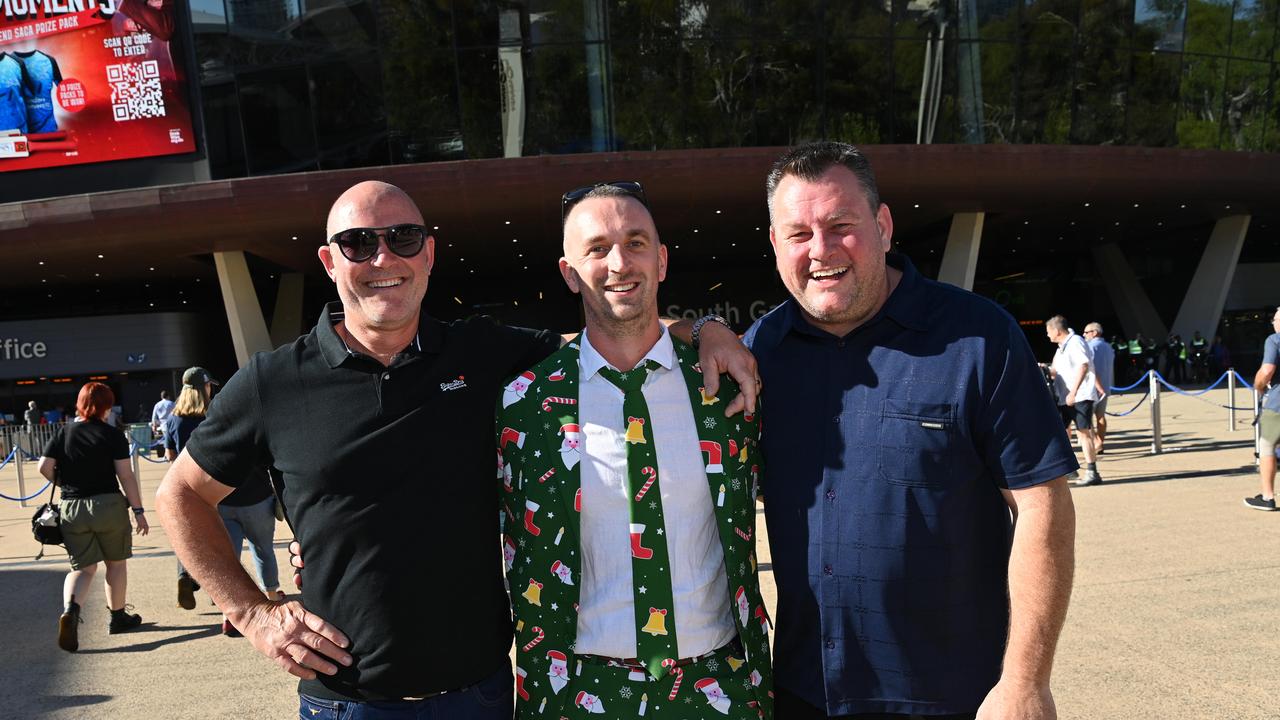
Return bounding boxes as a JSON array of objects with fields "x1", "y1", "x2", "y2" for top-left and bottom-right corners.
[{"x1": 600, "y1": 360, "x2": 676, "y2": 679}]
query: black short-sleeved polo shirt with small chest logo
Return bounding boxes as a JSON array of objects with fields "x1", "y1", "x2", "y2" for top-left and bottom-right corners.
[{"x1": 187, "y1": 302, "x2": 559, "y2": 700}]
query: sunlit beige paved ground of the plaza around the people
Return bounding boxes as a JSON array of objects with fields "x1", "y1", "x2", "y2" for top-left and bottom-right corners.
[{"x1": 0, "y1": 391, "x2": 1280, "y2": 720}]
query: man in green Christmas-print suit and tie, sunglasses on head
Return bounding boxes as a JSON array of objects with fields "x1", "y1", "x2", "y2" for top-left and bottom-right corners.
[{"x1": 497, "y1": 183, "x2": 773, "y2": 720}]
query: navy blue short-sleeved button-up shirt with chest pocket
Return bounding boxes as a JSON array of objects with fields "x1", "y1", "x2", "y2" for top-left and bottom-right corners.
[{"x1": 745, "y1": 254, "x2": 1078, "y2": 715}]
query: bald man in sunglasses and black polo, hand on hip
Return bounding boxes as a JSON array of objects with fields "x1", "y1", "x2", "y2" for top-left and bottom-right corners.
[{"x1": 157, "y1": 181, "x2": 754, "y2": 720}]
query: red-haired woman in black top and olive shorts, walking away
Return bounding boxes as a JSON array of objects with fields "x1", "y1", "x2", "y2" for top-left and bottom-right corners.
[{"x1": 40, "y1": 383, "x2": 150, "y2": 652}]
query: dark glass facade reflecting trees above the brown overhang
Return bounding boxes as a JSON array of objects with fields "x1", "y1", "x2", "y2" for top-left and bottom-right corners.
[{"x1": 191, "y1": 0, "x2": 1280, "y2": 177}]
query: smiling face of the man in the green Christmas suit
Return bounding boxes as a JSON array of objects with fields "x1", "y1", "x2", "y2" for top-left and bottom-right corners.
[{"x1": 559, "y1": 196, "x2": 667, "y2": 338}]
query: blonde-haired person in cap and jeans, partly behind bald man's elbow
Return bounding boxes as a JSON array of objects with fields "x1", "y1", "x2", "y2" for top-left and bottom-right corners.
[{"x1": 165, "y1": 366, "x2": 284, "y2": 637}]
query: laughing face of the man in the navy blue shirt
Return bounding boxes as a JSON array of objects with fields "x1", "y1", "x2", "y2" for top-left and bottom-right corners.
[{"x1": 769, "y1": 165, "x2": 893, "y2": 336}]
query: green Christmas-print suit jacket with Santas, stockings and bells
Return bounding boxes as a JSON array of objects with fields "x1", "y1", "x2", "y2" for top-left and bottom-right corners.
[{"x1": 497, "y1": 336, "x2": 773, "y2": 717}]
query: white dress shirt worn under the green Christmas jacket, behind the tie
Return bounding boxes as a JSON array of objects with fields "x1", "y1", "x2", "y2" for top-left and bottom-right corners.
[{"x1": 575, "y1": 328, "x2": 737, "y2": 657}]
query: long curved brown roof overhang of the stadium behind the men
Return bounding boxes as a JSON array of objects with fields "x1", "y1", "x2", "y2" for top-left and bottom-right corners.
[{"x1": 0, "y1": 145, "x2": 1280, "y2": 293}]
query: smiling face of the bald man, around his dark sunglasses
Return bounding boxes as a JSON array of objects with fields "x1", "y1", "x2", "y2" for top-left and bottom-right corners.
[{"x1": 319, "y1": 182, "x2": 435, "y2": 332}]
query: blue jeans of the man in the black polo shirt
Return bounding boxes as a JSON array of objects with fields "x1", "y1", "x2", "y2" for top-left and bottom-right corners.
[{"x1": 298, "y1": 664, "x2": 516, "y2": 720}]
